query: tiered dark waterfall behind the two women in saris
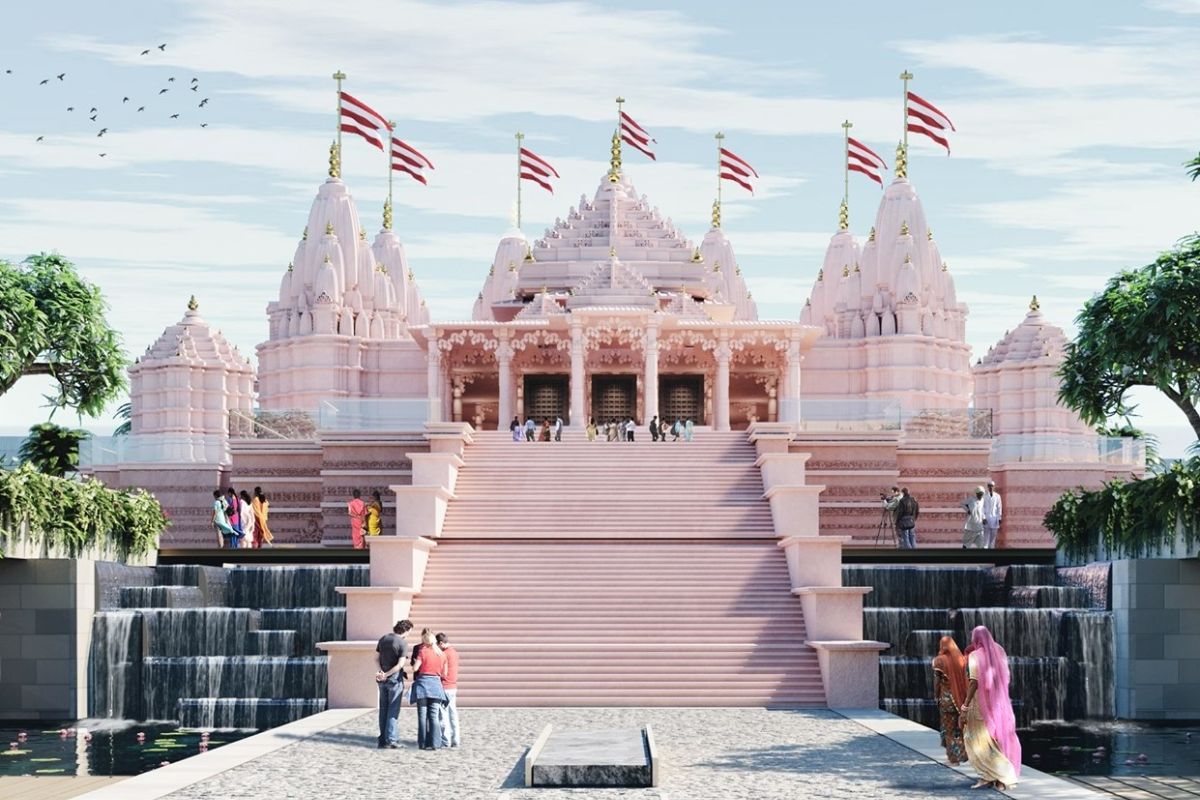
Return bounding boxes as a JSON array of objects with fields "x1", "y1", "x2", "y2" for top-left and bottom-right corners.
[{"x1": 842, "y1": 565, "x2": 1115, "y2": 727}]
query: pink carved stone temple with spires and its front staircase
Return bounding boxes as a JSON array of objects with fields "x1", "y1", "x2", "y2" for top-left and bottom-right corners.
[{"x1": 79, "y1": 87, "x2": 1142, "y2": 706}]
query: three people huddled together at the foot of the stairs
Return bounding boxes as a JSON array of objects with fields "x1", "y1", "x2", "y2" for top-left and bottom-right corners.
[{"x1": 376, "y1": 619, "x2": 461, "y2": 750}]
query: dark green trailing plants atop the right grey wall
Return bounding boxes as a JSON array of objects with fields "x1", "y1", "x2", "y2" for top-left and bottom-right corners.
[{"x1": 1043, "y1": 457, "x2": 1200, "y2": 559}]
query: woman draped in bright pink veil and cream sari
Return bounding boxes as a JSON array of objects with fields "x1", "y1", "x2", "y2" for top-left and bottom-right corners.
[{"x1": 961, "y1": 625, "x2": 1021, "y2": 789}]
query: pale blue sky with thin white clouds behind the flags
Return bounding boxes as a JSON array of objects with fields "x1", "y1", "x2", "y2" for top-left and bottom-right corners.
[{"x1": 0, "y1": 0, "x2": 1200, "y2": 455}]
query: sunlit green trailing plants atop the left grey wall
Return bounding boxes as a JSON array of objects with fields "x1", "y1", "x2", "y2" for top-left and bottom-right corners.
[{"x1": 0, "y1": 464, "x2": 170, "y2": 559}]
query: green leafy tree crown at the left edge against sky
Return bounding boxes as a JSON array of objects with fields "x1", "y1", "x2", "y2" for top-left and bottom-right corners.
[{"x1": 0, "y1": 253, "x2": 125, "y2": 416}]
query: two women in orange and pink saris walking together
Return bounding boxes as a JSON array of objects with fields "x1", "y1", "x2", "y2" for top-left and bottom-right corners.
[{"x1": 934, "y1": 625, "x2": 1021, "y2": 790}]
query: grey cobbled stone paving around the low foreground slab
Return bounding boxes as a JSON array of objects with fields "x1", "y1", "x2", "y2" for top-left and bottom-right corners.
[{"x1": 169, "y1": 706, "x2": 1001, "y2": 800}]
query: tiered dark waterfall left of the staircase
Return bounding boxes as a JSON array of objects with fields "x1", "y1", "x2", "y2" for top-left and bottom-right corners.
[{"x1": 89, "y1": 566, "x2": 370, "y2": 729}]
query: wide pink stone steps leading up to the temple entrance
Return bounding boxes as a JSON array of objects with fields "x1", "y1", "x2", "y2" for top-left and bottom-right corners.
[{"x1": 412, "y1": 432, "x2": 824, "y2": 706}]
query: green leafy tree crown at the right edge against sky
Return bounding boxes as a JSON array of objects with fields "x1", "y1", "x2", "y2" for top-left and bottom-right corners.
[{"x1": 1058, "y1": 231, "x2": 1200, "y2": 439}]
